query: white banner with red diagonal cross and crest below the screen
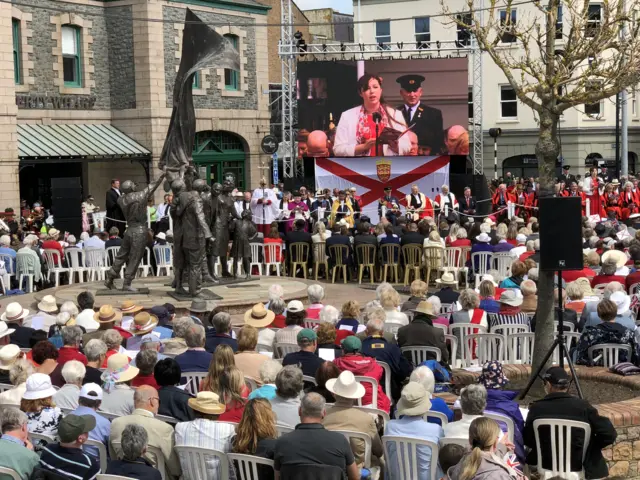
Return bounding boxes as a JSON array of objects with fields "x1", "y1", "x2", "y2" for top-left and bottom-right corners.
[{"x1": 315, "y1": 155, "x2": 449, "y2": 224}]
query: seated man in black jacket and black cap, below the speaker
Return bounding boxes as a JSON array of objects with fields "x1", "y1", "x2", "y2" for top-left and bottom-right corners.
[{"x1": 523, "y1": 367, "x2": 617, "y2": 478}]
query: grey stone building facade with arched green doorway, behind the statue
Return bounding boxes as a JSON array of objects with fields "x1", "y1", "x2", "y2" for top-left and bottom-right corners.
[{"x1": 0, "y1": 0, "x2": 269, "y2": 221}]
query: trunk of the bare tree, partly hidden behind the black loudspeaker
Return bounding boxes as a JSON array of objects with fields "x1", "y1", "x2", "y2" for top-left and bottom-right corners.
[{"x1": 532, "y1": 109, "x2": 560, "y2": 395}]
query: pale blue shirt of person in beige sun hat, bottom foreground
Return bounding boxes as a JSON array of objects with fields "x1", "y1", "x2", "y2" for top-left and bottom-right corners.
[{"x1": 384, "y1": 416, "x2": 444, "y2": 480}]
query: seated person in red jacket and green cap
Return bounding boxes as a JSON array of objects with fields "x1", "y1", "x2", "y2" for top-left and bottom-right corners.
[{"x1": 333, "y1": 335, "x2": 391, "y2": 413}]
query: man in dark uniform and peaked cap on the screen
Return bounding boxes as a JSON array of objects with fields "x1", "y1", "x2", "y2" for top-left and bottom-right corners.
[{"x1": 396, "y1": 75, "x2": 444, "y2": 155}]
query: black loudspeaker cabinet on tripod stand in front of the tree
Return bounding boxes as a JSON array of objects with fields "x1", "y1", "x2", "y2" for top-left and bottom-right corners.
[{"x1": 539, "y1": 197, "x2": 583, "y2": 271}]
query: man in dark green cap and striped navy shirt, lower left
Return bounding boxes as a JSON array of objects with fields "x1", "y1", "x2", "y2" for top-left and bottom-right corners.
[{"x1": 40, "y1": 414, "x2": 100, "y2": 480}]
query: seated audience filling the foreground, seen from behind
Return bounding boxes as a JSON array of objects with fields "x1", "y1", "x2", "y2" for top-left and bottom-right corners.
[{"x1": 0, "y1": 251, "x2": 624, "y2": 480}]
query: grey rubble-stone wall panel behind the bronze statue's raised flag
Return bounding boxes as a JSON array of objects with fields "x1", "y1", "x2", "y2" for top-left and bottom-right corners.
[{"x1": 163, "y1": 7, "x2": 260, "y2": 110}]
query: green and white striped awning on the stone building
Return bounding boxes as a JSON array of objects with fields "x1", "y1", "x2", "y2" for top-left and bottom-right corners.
[{"x1": 18, "y1": 124, "x2": 151, "y2": 160}]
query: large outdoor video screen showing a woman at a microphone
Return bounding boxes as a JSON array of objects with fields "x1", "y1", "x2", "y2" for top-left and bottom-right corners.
[{"x1": 297, "y1": 58, "x2": 469, "y2": 158}]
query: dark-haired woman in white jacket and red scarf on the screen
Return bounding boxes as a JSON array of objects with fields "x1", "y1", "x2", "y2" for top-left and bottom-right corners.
[{"x1": 333, "y1": 74, "x2": 411, "y2": 157}]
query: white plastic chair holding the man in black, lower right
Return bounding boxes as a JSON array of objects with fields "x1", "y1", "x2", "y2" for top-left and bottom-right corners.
[{"x1": 533, "y1": 418, "x2": 591, "y2": 476}]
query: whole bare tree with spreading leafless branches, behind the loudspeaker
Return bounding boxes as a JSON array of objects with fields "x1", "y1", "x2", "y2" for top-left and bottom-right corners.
[{"x1": 441, "y1": 0, "x2": 640, "y2": 386}]
